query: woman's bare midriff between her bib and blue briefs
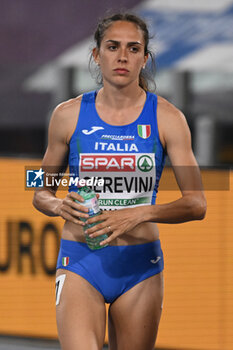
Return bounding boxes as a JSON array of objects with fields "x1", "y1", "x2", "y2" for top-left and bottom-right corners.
[{"x1": 62, "y1": 221, "x2": 159, "y2": 245}]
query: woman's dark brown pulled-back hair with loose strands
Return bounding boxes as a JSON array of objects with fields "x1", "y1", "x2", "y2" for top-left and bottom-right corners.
[{"x1": 89, "y1": 12, "x2": 155, "y2": 91}]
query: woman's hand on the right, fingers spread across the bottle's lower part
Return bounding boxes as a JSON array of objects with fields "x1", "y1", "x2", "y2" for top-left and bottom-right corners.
[{"x1": 85, "y1": 207, "x2": 143, "y2": 245}]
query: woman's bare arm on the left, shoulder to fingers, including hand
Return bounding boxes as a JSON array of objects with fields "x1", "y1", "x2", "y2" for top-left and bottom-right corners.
[{"x1": 33, "y1": 98, "x2": 88, "y2": 225}]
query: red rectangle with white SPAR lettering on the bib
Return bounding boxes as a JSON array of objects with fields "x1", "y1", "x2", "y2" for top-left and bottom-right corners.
[{"x1": 80, "y1": 154, "x2": 136, "y2": 172}]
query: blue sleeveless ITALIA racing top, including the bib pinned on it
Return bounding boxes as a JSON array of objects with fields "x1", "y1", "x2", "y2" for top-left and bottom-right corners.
[{"x1": 69, "y1": 91, "x2": 165, "y2": 210}]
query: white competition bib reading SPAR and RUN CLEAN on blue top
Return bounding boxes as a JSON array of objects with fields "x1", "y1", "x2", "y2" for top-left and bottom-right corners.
[{"x1": 79, "y1": 153, "x2": 156, "y2": 210}]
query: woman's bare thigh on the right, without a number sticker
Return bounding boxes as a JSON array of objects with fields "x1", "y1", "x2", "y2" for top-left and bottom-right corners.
[{"x1": 108, "y1": 272, "x2": 163, "y2": 350}]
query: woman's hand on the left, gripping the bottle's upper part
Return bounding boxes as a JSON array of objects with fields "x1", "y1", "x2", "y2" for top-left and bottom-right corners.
[{"x1": 57, "y1": 192, "x2": 89, "y2": 226}]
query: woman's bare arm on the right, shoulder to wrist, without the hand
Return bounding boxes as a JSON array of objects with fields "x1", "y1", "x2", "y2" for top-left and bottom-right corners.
[{"x1": 143, "y1": 101, "x2": 206, "y2": 224}]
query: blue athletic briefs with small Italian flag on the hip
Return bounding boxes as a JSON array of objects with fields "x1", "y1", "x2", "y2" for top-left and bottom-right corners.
[{"x1": 57, "y1": 239, "x2": 164, "y2": 303}]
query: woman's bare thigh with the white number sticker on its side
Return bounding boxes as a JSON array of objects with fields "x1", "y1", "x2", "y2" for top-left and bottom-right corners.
[{"x1": 56, "y1": 269, "x2": 106, "y2": 350}]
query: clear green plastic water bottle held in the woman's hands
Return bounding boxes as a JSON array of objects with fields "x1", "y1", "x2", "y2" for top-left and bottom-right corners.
[{"x1": 75, "y1": 186, "x2": 108, "y2": 250}]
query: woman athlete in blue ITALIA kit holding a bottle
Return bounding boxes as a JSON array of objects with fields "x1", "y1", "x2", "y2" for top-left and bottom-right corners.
[{"x1": 33, "y1": 13, "x2": 206, "y2": 350}]
